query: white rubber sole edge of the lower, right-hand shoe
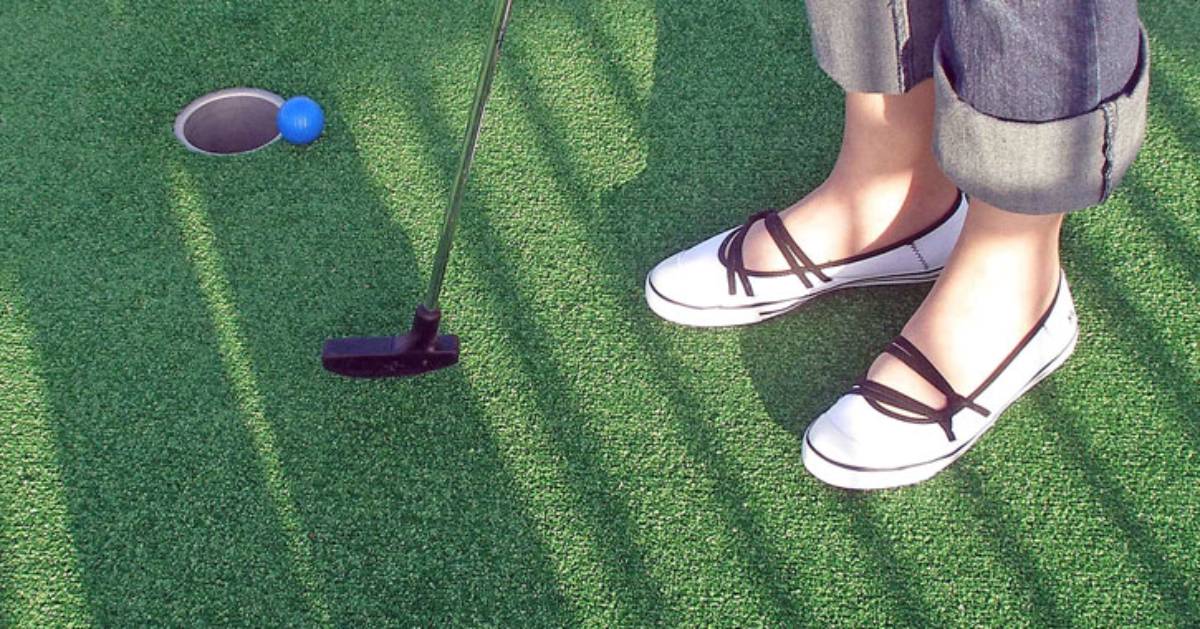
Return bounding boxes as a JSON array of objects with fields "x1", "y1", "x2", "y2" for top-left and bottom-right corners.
[{"x1": 800, "y1": 330, "x2": 1079, "y2": 490}]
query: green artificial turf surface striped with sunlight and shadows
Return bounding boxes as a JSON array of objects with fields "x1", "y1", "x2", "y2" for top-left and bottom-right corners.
[{"x1": 0, "y1": 0, "x2": 1200, "y2": 627}]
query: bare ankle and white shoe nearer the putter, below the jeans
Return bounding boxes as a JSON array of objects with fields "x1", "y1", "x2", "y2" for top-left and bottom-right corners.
[{"x1": 646, "y1": 82, "x2": 962, "y2": 327}]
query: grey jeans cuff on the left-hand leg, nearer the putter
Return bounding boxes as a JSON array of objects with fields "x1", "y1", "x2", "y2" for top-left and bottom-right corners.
[{"x1": 805, "y1": 0, "x2": 942, "y2": 94}]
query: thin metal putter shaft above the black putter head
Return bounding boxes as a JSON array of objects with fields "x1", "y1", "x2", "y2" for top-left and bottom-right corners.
[{"x1": 425, "y1": 0, "x2": 512, "y2": 311}]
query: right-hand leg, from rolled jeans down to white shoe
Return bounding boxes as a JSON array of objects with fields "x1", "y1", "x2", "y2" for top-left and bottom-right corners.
[{"x1": 803, "y1": 0, "x2": 1148, "y2": 489}]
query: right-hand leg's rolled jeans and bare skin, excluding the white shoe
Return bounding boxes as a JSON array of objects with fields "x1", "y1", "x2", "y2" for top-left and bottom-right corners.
[{"x1": 869, "y1": 0, "x2": 1146, "y2": 406}]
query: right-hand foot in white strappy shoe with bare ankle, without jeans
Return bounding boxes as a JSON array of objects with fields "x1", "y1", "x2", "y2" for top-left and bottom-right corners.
[{"x1": 804, "y1": 202, "x2": 1076, "y2": 489}]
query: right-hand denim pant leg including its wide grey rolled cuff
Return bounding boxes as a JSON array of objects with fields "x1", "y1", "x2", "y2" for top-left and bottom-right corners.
[{"x1": 934, "y1": 0, "x2": 1150, "y2": 214}]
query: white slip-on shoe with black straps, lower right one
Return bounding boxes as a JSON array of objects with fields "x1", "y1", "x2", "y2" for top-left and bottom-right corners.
[{"x1": 802, "y1": 275, "x2": 1079, "y2": 490}]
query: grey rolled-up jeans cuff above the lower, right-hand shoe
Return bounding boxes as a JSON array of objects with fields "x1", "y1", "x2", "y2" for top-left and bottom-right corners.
[{"x1": 934, "y1": 30, "x2": 1150, "y2": 214}]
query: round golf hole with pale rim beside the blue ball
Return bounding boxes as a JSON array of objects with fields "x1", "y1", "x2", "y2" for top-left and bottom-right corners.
[{"x1": 175, "y1": 88, "x2": 283, "y2": 155}]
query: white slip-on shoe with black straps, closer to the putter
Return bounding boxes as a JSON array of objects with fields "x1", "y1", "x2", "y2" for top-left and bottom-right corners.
[{"x1": 646, "y1": 193, "x2": 967, "y2": 328}]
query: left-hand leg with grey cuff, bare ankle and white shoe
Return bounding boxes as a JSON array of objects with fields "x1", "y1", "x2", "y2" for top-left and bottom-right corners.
[{"x1": 646, "y1": 0, "x2": 966, "y2": 327}]
